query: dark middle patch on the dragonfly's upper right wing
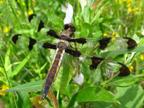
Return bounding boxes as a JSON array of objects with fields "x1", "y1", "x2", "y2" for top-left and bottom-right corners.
[{"x1": 98, "y1": 37, "x2": 111, "y2": 50}]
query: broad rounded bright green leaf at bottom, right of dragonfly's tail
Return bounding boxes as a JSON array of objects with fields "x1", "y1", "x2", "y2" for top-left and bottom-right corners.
[{"x1": 76, "y1": 87, "x2": 116, "y2": 102}]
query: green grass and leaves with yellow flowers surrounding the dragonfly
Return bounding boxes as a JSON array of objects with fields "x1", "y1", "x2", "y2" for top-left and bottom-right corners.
[{"x1": 0, "y1": 0, "x2": 144, "y2": 108}]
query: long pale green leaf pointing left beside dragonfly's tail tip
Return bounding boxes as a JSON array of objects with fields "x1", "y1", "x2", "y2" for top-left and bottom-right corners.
[{"x1": 7, "y1": 80, "x2": 44, "y2": 92}]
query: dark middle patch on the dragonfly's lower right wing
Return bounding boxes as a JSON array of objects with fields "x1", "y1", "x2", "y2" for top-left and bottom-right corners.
[{"x1": 90, "y1": 56, "x2": 104, "y2": 70}]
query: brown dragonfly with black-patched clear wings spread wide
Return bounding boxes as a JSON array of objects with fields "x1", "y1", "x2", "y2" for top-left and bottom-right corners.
[{"x1": 12, "y1": 4, "x2": 137, "y2": 98}]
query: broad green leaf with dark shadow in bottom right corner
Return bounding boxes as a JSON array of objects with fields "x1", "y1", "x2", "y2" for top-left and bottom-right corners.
[{"x1": 116, "y1": 85, "x2": 144, "y2": 108}]
